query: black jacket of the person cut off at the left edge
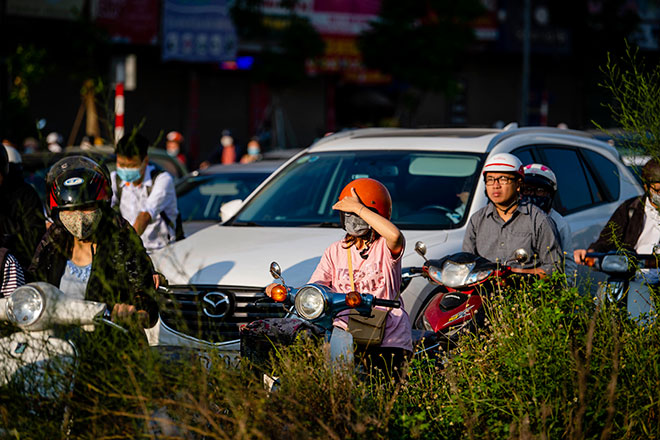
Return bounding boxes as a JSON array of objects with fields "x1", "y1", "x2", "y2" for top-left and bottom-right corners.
[{"x1": 0, "y1": 178, "x2": 46, "y2": 269}]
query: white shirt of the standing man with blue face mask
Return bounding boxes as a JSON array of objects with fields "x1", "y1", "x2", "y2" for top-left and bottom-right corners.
[{"x1": 110, "y1": 165, "x2": 179, "y2": 253}]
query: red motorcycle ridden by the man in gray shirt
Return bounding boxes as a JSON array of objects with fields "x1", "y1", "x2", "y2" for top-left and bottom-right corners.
[{"x1": 407, "y1": 241, "x2": 529, "y2": 351}]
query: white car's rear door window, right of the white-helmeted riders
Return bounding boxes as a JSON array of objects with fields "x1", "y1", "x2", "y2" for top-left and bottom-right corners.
[{"x1": 540, "y1": 147, "x2": 594, "y2": 215}]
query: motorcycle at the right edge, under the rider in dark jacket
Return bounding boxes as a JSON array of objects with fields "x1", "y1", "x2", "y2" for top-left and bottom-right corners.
[{"x1": 585, "y1": 249, "x2": 660, "y2": 319}]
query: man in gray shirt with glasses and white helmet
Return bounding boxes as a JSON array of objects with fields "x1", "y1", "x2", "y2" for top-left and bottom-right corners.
[{"x1": 463, "y1": 153, "x2": 561, "y2": 276}]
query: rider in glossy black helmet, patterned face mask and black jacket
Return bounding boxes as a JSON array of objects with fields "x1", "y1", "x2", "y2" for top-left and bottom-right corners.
[{"x1": 29, "y1": 156, "x2": 158, "y2": 326}]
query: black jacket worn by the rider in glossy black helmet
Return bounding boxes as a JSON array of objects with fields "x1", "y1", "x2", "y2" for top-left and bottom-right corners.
[{"x1": 28, "y1": 208, "x2": 158, "y2": 325}]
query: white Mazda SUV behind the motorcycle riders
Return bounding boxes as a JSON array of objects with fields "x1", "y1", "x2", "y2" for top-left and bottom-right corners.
[{"x1": 148, "y1": 127, "x2": 642, "y2": 349}]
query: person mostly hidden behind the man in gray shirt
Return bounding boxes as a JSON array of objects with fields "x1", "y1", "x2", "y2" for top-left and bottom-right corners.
[{"x1": 521, "y1": 163, "x2": 577, "y2": 277}]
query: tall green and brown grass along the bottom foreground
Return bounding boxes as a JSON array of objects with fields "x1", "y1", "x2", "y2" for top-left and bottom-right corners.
[{"x1": 0, "y1": 279, "x2": 660, "y2": 440}]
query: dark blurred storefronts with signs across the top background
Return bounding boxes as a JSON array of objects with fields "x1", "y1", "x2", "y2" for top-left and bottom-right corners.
[{"x1": 0, "y1": 0, "x2": 660, "y2": 167}]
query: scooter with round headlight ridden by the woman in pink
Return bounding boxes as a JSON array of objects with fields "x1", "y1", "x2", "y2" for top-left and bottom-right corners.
[{"x1": 241, "y1": 262, "x2": 401, "y2": 379}]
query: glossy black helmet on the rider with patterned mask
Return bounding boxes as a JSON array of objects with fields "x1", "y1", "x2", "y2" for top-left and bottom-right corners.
[{"x1": 46, "y1": 156, "x2": 112, "y2": 220}]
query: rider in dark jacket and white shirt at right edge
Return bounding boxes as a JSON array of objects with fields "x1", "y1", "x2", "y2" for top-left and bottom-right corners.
[{"x1": 573, "y1": 158, "x2": 660, "y2": 264}]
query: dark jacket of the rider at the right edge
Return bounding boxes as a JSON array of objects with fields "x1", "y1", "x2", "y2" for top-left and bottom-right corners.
[{"x1": 589, "y1": 197, "x2": 644, "y2": 252}]
